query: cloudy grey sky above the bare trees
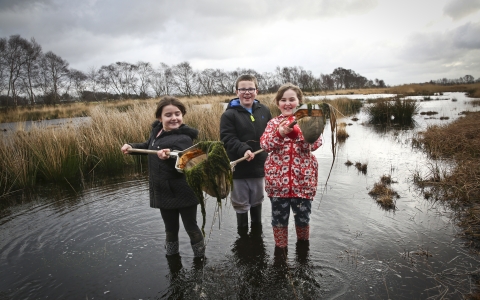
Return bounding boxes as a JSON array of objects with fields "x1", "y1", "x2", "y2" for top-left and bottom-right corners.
[{"x1": 0, "y1": 0, "x2": 480, "y2": 85}]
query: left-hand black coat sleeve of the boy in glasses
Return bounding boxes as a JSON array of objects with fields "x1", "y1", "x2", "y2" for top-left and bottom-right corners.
[{"x1": 220, "y1": 111, "x2": 253, "y2": 159}]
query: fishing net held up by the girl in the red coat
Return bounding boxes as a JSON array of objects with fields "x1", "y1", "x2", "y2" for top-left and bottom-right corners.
[{"x1": 295, "y1": 103, "x2": 328, "y2": 144}]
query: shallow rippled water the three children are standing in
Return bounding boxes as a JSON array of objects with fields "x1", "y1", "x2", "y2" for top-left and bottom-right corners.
[{"x1": 0, "y1": 93, "x2": 480, "y2": 299}]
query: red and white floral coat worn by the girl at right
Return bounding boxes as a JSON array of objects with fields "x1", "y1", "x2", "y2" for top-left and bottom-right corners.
[{"x1": 260, "y1": 115, "x2": 322, "y2": 200}]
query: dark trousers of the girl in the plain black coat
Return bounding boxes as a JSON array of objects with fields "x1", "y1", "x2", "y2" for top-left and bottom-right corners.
[{"x1": 160, "y1": 205, "x2": 203, "y2": 245}]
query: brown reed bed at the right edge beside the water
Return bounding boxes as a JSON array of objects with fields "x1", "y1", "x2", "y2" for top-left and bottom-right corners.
[{"x1": 414, "y1": 112, "x2": 480, "y2": 249}]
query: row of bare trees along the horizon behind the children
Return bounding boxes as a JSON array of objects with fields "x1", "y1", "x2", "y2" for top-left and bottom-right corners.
[{"x1": 0, "y1": 35, "x2": 386, "y2": 107}]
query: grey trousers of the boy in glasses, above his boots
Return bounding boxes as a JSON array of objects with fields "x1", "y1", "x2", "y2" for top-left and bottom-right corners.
[{"x1": 230, "y1": 177, "x2": 265, "y2": 214}]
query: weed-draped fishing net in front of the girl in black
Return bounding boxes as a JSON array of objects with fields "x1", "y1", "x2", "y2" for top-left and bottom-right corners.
[{"x1": 183, "y1": 141, "x2": 233, "y2": 234}]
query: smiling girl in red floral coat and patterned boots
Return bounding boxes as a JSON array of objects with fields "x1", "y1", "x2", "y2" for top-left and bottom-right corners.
[{"x1": 260, "y1": 83, "x2": 322, "y2": 248}]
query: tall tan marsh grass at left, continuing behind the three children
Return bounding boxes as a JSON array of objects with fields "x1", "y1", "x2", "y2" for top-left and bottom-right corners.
[{"x1": 0, "y1": 95, "x2": 366, "y2": 197}]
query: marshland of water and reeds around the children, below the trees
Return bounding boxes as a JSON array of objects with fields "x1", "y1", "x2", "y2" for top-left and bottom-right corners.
[{"x1": 0, "y1": 85, "x2": 480, "y2": 299}]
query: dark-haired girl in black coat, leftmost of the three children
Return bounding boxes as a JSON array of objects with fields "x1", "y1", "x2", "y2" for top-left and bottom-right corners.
[{"x1": 121, "y1": 96, "x2": 205, "y2": 257}]
